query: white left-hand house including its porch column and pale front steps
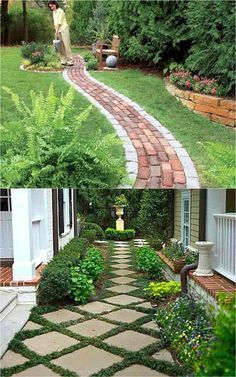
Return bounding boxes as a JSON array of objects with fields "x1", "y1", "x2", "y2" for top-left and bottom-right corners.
[{"x1": 0, "y1": 189, "x2": 77, "y2": 356}]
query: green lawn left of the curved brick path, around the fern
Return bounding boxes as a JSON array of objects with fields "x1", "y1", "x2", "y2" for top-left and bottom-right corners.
[{"x1": 1, "y1": 47, "x2": 125, "y2": 186}]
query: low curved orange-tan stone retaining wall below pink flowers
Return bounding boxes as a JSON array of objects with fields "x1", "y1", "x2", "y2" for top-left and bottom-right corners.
[{"x1": 165, "y1": 80, "x2": 236, "y2": 127}]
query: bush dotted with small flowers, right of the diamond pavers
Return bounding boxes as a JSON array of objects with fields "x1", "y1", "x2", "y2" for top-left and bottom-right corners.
[{"x1": 156, "y1": 295, "x2": 213, "y2": 371}]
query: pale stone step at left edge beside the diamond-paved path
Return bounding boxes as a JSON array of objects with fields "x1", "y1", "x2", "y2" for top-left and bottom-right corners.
[{"x1": 0, "y1": 304, "x2": 34, "y2": 357}]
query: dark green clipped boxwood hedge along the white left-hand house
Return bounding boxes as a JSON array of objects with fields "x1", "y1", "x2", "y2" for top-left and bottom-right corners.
[{"x1": 38, "y1": 237, "x2": 88, "y2": 304}]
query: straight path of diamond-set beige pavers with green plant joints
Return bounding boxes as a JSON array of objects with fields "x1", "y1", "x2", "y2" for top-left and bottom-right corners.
[{"x1": 2, "y1": 240, "x2": 182, "y2": 377}]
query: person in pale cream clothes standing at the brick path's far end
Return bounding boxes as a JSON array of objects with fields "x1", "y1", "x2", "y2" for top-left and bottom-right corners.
[{"x1": 48, "y1": 0, "x2": 73, "y2": 66}]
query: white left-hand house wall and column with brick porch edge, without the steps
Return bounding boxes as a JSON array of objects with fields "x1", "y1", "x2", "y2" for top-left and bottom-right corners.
[{"x1": 0, "y1": 189, "x2": 77, "y2": 290}]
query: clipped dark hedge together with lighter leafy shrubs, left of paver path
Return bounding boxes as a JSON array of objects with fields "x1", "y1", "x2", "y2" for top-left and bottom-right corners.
[{"x1": 38, "y1": 237, "x2": 104, "y2": 304}]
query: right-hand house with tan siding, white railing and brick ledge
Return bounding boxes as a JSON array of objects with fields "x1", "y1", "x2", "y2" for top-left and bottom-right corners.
[{"x1": 168, "y1": 189, "x2": 236, "y2": 304}]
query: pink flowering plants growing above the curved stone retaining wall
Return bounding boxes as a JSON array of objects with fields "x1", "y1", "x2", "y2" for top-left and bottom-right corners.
[{"x1": 170, "y1": 70, "x2": 225, "y2": 96}]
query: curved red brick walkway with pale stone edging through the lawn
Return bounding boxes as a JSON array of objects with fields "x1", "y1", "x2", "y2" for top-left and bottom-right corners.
[{"x1": 63, "y1": 56, "x2": 199, "y2": 188}]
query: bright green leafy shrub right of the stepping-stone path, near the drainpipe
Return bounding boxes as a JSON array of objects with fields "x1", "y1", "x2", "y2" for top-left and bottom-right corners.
[{"x1": 134, "y1": 246, "x2": 165, "y2": 280}]
